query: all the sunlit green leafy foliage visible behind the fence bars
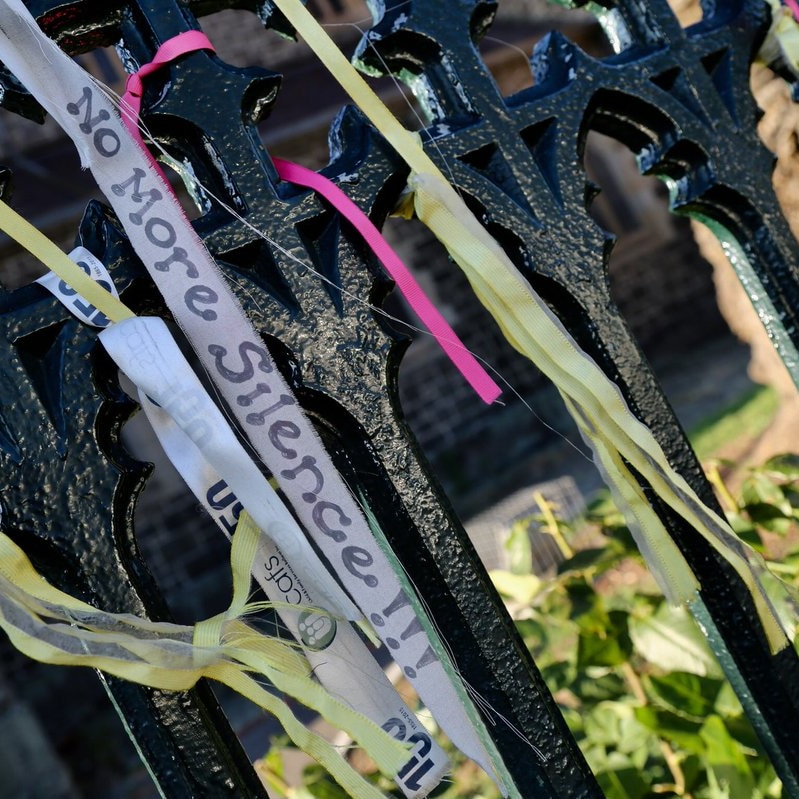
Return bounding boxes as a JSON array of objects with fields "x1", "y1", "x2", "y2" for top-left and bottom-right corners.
[{"x1": 261, "y1": 456, "x2": 799, "y2": 799}]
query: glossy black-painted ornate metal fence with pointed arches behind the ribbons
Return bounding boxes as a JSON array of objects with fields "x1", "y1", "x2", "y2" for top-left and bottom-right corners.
[{"x1": 0, "y1": 0, "x2": 799, "y2": 799}]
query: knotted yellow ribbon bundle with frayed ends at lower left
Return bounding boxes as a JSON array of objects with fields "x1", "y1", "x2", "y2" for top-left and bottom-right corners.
[{"x1": 0, "y1": 513, "x2": 408, "y2": 799}]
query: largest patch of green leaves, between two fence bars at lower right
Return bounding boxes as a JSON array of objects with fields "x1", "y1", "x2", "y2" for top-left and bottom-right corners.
[{"x1": 499, "y1": 488, "x2": 780, "y2": 799}]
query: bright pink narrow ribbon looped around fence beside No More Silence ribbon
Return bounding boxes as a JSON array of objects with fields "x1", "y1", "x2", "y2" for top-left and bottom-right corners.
[{"x1": 121, "y1": 31, "x2": 502, "y2": 405}]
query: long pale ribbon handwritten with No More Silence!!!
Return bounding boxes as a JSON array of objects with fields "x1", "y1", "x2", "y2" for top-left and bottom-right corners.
[{"x1": 0, "y1": 0, "x2": 507, "y2": 791}]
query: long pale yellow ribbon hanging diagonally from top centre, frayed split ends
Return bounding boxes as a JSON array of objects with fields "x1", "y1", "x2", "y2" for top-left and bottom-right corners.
[{"x1": 274, "y1": 0, "x2": 789, "y2": 652}]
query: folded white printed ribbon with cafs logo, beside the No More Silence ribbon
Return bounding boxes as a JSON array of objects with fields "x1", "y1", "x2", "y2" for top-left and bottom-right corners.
[{"x1": 100, "y1": 317, "x2": 449, "y2": 799}]
